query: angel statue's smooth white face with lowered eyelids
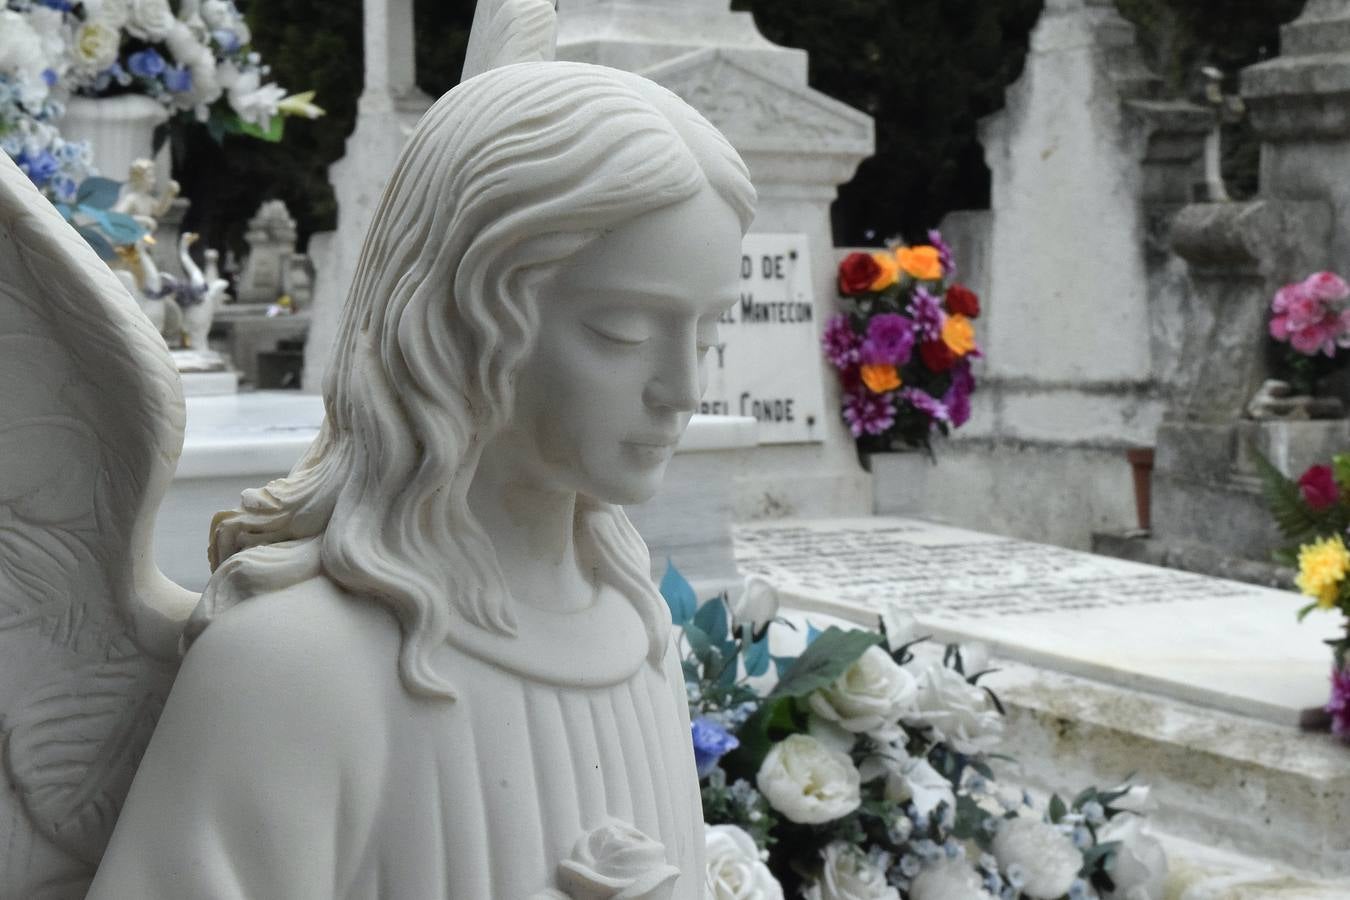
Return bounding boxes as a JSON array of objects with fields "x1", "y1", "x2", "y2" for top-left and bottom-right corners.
[{"x1": 494, "y1": 189, "x2": 741, "y2": 503}]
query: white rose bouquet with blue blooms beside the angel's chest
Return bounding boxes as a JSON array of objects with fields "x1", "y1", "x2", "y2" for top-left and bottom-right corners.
[{"x1": 662, "y1": 568, "x2": 1166, "y2": 900}]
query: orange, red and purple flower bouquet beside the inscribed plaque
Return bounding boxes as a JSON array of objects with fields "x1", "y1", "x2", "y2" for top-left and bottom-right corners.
[{"x1": 824, "y1": 231, "x2": 980, "y2": 449}]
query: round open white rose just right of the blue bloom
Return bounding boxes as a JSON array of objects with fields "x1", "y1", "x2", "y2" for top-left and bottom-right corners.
[{"x1": 755, "y1": 734, "x2": 863, "y2": 824}]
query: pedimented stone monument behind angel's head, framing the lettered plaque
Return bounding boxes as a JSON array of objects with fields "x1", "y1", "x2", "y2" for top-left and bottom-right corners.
[{"x1": 558, "y1": 0, "x2": 875, "y2": 518}]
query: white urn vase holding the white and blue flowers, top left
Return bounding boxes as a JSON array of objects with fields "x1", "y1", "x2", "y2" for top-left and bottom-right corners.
[{"x1": 59, "y1": 94, "x2": 169, "y2": 181}]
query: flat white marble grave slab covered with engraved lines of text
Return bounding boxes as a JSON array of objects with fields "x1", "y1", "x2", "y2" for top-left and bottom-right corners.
[{"x1": 736, "y1": 517, "x2": 1335, "y2": 725}]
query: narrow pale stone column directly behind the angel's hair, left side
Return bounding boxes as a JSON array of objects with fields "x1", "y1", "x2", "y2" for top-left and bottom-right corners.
[{"x1": 304, "y1": 0, "x2": 431, "y2": 391}]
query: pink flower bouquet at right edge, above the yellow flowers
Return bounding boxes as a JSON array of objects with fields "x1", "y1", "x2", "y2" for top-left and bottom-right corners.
[{"x1": 1270, "y1": 271, "x2": 1350, "y2": 395}]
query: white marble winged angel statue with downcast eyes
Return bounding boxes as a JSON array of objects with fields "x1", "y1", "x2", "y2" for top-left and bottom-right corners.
[{"x1": 0, "y1": 0, "x2": 755, "y2": 900}]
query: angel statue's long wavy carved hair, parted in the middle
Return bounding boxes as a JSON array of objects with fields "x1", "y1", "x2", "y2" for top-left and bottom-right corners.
[{"x1": 188, "y1": 62, "x2": 755, "y2": 698}]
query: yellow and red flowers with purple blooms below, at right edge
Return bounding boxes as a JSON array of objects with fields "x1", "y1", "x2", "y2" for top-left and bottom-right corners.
[{"x1": 1256, "y1": 453, "x2": 1350, "y2": 742}]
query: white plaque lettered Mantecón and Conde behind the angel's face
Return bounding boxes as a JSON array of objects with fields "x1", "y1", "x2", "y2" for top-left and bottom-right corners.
[{"x1": 699, "y1": 233, "x2": 828, "y2": 444}]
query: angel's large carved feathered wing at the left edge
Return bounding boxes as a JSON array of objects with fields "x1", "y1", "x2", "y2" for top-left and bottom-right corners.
[{"x1": 0, "y1": 152, "x2": 197, "y2": 900}]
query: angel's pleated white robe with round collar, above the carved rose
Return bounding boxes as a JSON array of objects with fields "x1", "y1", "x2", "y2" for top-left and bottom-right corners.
[{"x1": 89, "y1": 578, "x2": 703, "y2": 900}]
